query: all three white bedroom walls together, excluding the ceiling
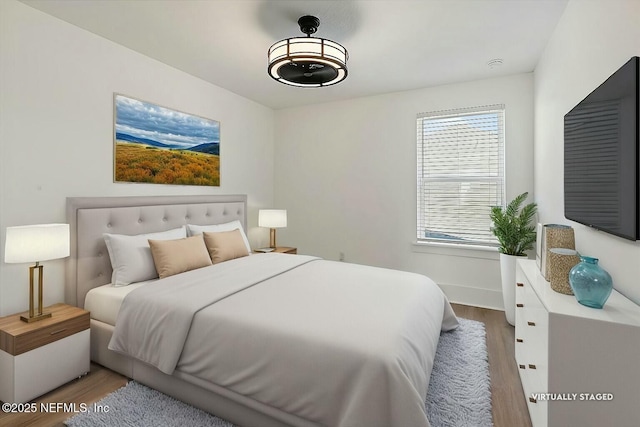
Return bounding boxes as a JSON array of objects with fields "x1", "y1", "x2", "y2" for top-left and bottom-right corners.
[{"x1": 8, "y1": 0, "x2": 640, "y2": 315}]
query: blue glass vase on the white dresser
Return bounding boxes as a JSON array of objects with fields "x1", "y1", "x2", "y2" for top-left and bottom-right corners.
[{"x1": 569, "y1": 256, "x2": 613, "y2": 308}]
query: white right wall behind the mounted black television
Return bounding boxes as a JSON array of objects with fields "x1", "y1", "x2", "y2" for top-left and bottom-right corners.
[{"x1": 534, "y1": 0, "x2": 640, "y2": 303}]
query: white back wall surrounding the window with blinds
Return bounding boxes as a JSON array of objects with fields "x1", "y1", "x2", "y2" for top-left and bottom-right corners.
[{"x1": 275, "y1": 74, "x2": 533, "y2": 308}]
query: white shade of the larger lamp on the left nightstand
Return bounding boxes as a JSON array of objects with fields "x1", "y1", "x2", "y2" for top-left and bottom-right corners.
[{"x1": 4, "y1": 224, "x2": 70, "y2": 264}]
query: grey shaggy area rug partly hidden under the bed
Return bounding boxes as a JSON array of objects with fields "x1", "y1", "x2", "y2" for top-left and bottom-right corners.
[{"x1": 65, "y1": 318, "x2": 493, "y2": 427}]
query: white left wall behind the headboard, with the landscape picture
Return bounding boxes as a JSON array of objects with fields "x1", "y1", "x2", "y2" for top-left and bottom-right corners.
[{"x1": 0, "y1": 0, "x2": 274, "y2": 315}]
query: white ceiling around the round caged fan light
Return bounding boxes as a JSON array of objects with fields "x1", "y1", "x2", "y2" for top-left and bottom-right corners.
[{"x1": 22, "y1": 0, "x2": 567, "y2": 109}]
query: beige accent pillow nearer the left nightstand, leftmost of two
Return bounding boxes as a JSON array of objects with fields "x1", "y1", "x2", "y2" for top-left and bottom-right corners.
[{"x1": 149, "y1": 236, "x2": 211, "y2": 279}]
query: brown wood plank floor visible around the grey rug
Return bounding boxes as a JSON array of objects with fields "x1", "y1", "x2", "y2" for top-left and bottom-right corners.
[{"x1": 0, "y1": 304, "x2": 531, "y2": 427}]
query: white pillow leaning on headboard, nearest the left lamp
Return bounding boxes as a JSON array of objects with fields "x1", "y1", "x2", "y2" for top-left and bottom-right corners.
[{"x1": 103, "y1": 225, "x2": 187, "y2": 286}]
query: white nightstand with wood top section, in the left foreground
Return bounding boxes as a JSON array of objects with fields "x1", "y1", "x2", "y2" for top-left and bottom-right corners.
[{"x1": 0, "y1": 304, "x2": 90, "y2": 403}]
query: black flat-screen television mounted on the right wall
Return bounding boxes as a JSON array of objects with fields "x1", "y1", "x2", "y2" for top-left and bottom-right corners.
[{"x1": 564, "y1": 56, "x2": 640, "y2": 240}]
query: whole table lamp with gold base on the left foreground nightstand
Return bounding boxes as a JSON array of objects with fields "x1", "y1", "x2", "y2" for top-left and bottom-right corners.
[{"x1": 4, "y1": 224, "x2": 69, "y2": 323}]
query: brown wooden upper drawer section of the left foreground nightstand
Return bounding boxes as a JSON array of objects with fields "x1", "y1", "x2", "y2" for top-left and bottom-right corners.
[{"x1": 0, "y1": 304, "x2": 89, "y2": 356}]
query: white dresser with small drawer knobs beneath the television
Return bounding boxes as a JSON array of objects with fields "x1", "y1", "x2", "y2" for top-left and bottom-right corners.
[{"x1": 515, "y1": 260, "x2": 640, "y2": 427}]
